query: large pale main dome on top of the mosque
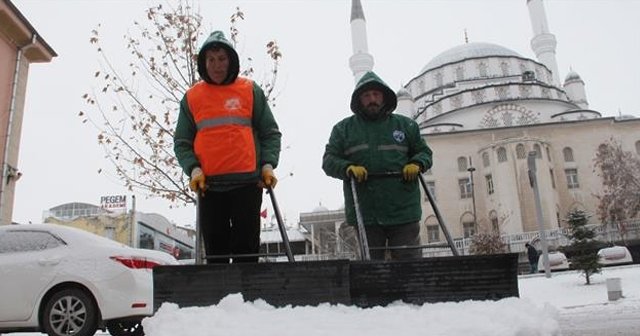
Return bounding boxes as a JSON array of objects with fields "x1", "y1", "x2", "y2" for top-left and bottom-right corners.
[{"x1": 420, "y1": 42, "x2": 522, "y2": 73}]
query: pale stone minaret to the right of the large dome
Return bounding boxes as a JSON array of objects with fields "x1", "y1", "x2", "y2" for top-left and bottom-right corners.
[{"x1": 527, "y1": 0, "x2": 561, "y2": 86}]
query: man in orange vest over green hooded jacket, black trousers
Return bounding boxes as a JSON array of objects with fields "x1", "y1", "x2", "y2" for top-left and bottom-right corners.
[{"x1": 174, "y1": 31, "x2": 282, "y2": 263}]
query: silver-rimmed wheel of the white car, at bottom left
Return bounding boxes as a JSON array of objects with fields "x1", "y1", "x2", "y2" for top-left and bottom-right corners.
[{"x1": 42, "y1": 288, "x2": 98, "y2": 336}]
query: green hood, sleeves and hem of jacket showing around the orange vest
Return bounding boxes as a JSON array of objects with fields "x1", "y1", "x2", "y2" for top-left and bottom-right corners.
[{"x1": 173, "y1": 31, "x2": 282, "y2": 190}]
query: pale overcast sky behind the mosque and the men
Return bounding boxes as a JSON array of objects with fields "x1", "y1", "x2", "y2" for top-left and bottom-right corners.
[{"x1": 12, "y1": 0, "x2": 640, "y2": 225}]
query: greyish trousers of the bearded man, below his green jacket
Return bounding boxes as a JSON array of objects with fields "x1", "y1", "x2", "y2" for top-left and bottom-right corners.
[{"x1": 365, "y1": 222, "x2": 422, "y2": 260}]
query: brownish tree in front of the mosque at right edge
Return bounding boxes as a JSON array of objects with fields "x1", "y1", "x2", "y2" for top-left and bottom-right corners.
[{"x1": 594, "y1": 138, "x2": 640, "y2": 240}]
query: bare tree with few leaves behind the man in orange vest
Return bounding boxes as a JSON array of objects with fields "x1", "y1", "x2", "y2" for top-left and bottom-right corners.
[{"x1": 79, "y1": 0, "x2": 282, "y2": 206}]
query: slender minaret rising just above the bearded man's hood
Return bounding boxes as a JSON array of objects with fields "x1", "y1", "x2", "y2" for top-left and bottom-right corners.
[{"x1": 349, "y1": 0, "x2": 373, "y2": 83}]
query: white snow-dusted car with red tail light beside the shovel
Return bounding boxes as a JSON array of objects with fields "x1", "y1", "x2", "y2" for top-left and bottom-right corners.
[{"x1": 0, "y1": 224, "x2": 177, "y2": 336}]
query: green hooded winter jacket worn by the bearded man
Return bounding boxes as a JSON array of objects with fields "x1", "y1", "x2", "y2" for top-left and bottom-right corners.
[{"x1": 322, "y1": 72, "x2": 432, "y2": 225}]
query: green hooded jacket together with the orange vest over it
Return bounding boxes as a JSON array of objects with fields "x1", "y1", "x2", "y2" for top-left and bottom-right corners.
[{"x1": 174, "y1": 31, "x2": 281, "y2": 190}]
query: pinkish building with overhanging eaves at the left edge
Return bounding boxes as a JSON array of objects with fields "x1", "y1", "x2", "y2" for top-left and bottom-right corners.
[{"x1": 0, "y1": 0, "x2": 57, "y2": 225}]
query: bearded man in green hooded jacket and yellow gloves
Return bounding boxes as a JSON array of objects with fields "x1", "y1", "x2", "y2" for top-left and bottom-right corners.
[{"x1": 322, "y1": 71, "x2": 432, "y2": 260}]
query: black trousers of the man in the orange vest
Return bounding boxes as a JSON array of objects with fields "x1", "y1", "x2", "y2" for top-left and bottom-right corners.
[{"x1": 199, "y1": 184, "x2": 262, "y2": 264}]
